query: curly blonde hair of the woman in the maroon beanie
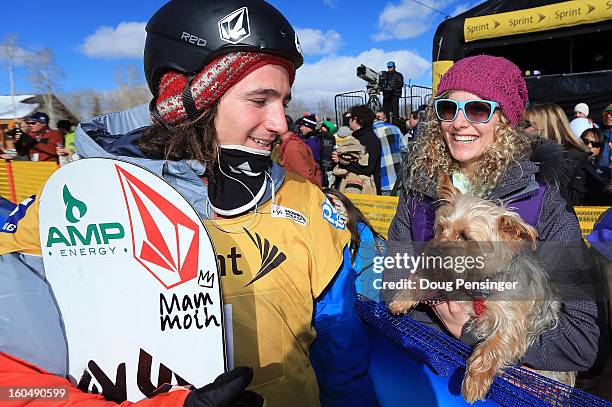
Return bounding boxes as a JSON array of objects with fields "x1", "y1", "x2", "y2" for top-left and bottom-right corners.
[{"x1": 404, "y1": 92, "x2": 531, "y2": 197}]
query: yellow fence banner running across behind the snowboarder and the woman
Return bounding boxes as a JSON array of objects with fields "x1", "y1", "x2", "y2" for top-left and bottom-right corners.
[{"x1": 0, "y1": 160, "x2": 608, "y2": 237}]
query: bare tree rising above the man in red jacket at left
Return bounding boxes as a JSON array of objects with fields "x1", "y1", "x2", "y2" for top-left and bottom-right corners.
[{"x1": 27, "y1": 48, "x2": 64, "y2": 125}]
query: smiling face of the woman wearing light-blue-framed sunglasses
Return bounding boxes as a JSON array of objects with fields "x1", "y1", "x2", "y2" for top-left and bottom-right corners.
[{"x1": 440, "y1": 91, "x2": 499, "y2": 169}]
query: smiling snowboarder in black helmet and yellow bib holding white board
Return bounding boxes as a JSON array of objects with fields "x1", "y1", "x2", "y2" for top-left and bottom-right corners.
[{"x1": 0, "y1": 0, "x2": 376, "y2": 407}]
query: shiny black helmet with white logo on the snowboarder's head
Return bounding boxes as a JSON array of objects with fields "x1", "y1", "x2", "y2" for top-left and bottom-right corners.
[{"x1": 144, "y1": 0, "x2": 304, "y2": 97}]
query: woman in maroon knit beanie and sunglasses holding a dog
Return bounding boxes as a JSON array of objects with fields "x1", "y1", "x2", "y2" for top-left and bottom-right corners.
[{"x1": 384, "y1": 55, "x2": 605, "y2": 380}]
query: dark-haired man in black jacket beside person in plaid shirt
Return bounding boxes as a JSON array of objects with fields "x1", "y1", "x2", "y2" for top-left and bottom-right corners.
[{"x1": 332, "y1": 105, "x2": 382, "y2": 195}]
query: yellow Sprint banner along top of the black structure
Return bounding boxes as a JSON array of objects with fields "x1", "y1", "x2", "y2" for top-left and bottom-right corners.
[{"x1": 463, "y1": 0, "x2": 612, "y2": 42}]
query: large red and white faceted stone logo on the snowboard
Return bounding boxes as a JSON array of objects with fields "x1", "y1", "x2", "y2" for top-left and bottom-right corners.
[{"x1": 115, "y1": 165, "x2": 200, "y2": 288}]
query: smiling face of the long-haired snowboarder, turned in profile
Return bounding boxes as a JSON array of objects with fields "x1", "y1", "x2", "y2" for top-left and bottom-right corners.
[{"x1": 215, "y1": 65, "x2": 291, "y2": 151}]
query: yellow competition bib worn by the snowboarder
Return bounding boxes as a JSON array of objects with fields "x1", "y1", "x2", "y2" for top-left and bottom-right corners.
[{"x1": 206, "y1": 174, "x2": 350, "y2": 407}]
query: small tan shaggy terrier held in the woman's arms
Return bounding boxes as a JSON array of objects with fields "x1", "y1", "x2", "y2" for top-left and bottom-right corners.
[{"x1": 389, "y1": 176, "x2": 575, "y2": 403}]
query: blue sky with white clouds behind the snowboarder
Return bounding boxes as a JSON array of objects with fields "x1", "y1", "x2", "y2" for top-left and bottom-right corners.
[{"x1": 0, "y1": 0, "x2": 481, "y2": 107}]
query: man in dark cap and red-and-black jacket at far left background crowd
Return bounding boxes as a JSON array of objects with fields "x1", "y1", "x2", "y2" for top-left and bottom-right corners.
[{"x1": 15, "y1": 112, "x2": 64, "y2": 162}]
